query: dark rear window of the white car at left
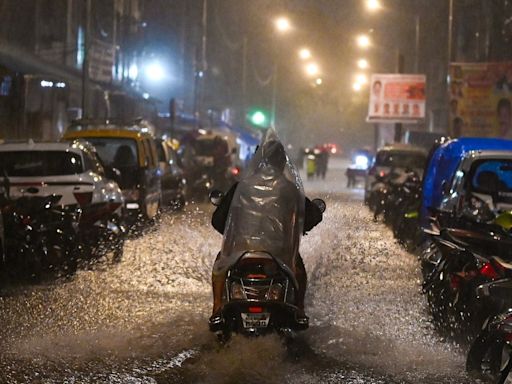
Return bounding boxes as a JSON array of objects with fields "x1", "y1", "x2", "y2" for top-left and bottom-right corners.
[{"x1": 0, "y1": 151, "x2": 83, "y2": 177}]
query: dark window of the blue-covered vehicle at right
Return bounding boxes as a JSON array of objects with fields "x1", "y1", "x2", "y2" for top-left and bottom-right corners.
[{"x1": 470, "y1": 159, "x2": 512, "y2": 200}]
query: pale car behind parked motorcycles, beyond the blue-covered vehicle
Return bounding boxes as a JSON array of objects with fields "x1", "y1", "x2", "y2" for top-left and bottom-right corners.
[{"x1": 364, "y1": 144, "x2": 427, "y2": 203}]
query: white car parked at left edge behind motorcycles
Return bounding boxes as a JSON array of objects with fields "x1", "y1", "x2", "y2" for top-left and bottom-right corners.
[{"x1": 0, "y1": 141, "x2": 123, "y2": 216}]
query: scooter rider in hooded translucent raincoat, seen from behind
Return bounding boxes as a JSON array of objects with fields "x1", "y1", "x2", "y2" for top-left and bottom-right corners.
[{"x1": 212, "y1": 132, "x2": 322, "y2": 319}]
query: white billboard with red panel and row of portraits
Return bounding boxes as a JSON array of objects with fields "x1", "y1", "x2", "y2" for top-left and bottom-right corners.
[{"x1": 367, "y1": 74, "x2": 426, "y2": 123}]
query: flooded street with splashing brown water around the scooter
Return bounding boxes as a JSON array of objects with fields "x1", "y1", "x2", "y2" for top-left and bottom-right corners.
[{"x1": 0, "y1": 163, "x2": 471, "y2": 383}]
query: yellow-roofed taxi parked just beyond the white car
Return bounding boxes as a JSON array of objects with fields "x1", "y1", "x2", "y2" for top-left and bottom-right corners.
[{"x1": 63, "y1": 120, "x2": 162, "y2": 223}]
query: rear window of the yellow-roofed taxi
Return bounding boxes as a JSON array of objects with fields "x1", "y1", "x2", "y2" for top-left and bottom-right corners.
[{"x1": 87, "y1": 137, "x2": 139, "y2": 169}]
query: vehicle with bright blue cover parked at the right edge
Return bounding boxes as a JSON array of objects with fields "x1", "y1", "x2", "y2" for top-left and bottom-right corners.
[{"x1": 420, "y1": 138, "x2": 512, "y2": 228}]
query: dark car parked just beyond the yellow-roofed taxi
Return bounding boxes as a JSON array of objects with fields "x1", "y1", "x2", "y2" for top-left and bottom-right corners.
[{"x1": 155, "y1": 139, "x2": 187, "y2": 208}]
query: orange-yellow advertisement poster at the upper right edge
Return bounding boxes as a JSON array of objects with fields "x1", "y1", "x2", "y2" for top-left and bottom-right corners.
[{"x1": 449, "y1": 62, "x2": 512, "y2": 138}]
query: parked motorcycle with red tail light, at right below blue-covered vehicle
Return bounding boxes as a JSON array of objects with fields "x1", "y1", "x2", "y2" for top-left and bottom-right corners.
[{"x1": 422, "y1": 219, "x2": 512, "y2": 331}]
